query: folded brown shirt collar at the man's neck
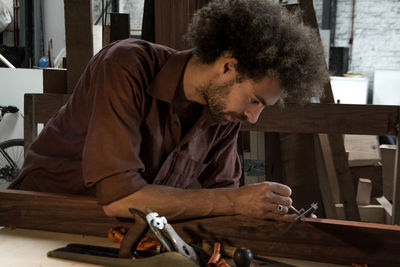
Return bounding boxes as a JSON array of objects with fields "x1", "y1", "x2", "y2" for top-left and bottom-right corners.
[{"x1": 148, "y1": 50, "x2": 192, "y2": 103}]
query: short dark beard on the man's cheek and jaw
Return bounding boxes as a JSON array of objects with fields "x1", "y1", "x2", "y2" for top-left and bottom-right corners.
[{"x1": 197, "y1": 79, "x2": 247, "y2": 124}]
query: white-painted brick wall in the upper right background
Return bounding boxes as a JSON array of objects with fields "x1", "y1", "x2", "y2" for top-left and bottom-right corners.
[{"x1": 314, "y1": 0, "x2": 400, "y2": 91}]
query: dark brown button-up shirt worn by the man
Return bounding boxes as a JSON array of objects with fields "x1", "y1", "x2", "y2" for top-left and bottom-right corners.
[{"x1": 12, "y1": 39, "x2": 240, "y2": 204}]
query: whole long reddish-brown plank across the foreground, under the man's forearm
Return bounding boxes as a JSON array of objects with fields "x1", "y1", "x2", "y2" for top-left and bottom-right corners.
[{"x1": 0, "y1": 190, "x2": 400, "y2": 266}]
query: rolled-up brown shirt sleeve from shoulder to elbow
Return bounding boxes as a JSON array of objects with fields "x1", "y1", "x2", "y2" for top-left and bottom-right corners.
[{"x1": 82, "y1": 44, "x2": 152, "y2": 205}]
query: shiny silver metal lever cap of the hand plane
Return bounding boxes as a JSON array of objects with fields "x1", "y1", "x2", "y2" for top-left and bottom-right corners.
[{"x1": 129, "y1": 209, "x2": 201, "y2": 265}]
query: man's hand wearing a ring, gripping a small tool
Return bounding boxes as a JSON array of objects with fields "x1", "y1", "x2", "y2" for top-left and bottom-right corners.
[{"x1": 233, "y1": 182, "x2": 297, "y2": 222}]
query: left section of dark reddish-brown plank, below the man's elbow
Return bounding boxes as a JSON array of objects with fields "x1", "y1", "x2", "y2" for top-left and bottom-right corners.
[{"x1": 0, "y1": 190, "x2": 127, "y2": 236}]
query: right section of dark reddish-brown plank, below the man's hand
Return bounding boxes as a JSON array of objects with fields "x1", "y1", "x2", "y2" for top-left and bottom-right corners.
[{"x1": 179, "y1": 216, "x2": 400, "y2": 266}]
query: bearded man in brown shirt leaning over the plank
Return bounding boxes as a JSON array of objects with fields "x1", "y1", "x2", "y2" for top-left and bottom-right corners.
[{"x1": 13, "y1": 0, "x2": 327, "y2": 221}]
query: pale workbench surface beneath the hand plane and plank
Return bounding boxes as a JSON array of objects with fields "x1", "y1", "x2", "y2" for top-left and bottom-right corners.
[{"x1": 0, "y1": 226, "x2": 346, "y2": 267}]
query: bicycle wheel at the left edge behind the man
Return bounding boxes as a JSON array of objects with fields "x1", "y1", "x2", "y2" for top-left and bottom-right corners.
[{"x1": 0, "y1": 139, "x2": 24, "y2": 188}]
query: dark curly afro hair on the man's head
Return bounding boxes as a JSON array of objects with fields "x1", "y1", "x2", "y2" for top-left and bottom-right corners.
[{"x1": 187, "y1": 0, "x2": 329, "y2": 103}]
